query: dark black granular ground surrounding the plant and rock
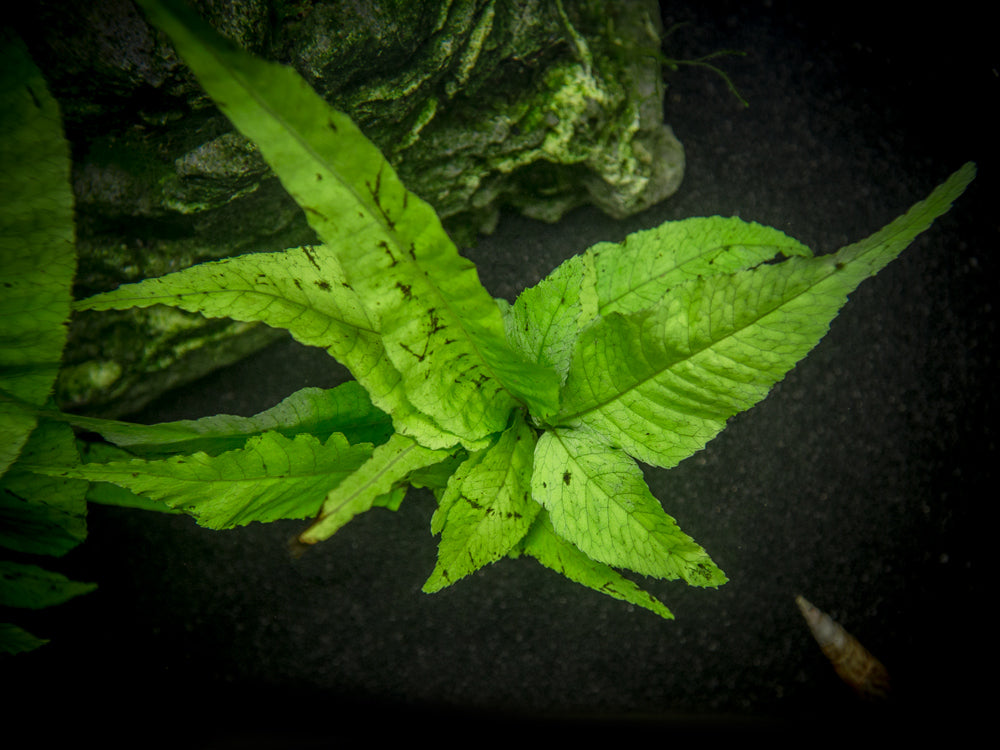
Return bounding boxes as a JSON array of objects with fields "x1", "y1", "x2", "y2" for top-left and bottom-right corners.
[{"x1": 2, "y1": 1, "x2": 1000, "y2": 747}]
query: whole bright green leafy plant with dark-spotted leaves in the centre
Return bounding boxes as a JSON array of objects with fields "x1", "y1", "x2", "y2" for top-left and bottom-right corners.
[{"x1": 3, "y1": 0, "x2": 975, "y2": 636}]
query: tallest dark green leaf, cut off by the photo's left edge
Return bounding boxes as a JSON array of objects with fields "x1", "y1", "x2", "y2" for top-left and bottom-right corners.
[{"x1": 0, "y1": 28, "x2": 76, "y2": 475}]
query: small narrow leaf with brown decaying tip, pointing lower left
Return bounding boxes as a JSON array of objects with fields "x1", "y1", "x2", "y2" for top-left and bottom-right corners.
[{"x1": 298, "y1": 433, "x2": 452, "y2": 544}]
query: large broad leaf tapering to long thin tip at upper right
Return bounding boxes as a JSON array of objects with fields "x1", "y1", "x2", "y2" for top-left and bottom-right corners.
[{"x1": 554, "y1": 164, "x2": 975, "y2": 467}]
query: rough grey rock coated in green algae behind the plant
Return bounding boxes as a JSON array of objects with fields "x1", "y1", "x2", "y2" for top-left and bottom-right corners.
[{"x1": 13, "y1": 0, "x2": 684, "y2": 415}]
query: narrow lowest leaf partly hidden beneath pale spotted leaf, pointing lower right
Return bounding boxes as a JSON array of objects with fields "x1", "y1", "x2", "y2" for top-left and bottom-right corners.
[{"x1": 511, "y1": 510, "x2": 674, "y2": 620}]
